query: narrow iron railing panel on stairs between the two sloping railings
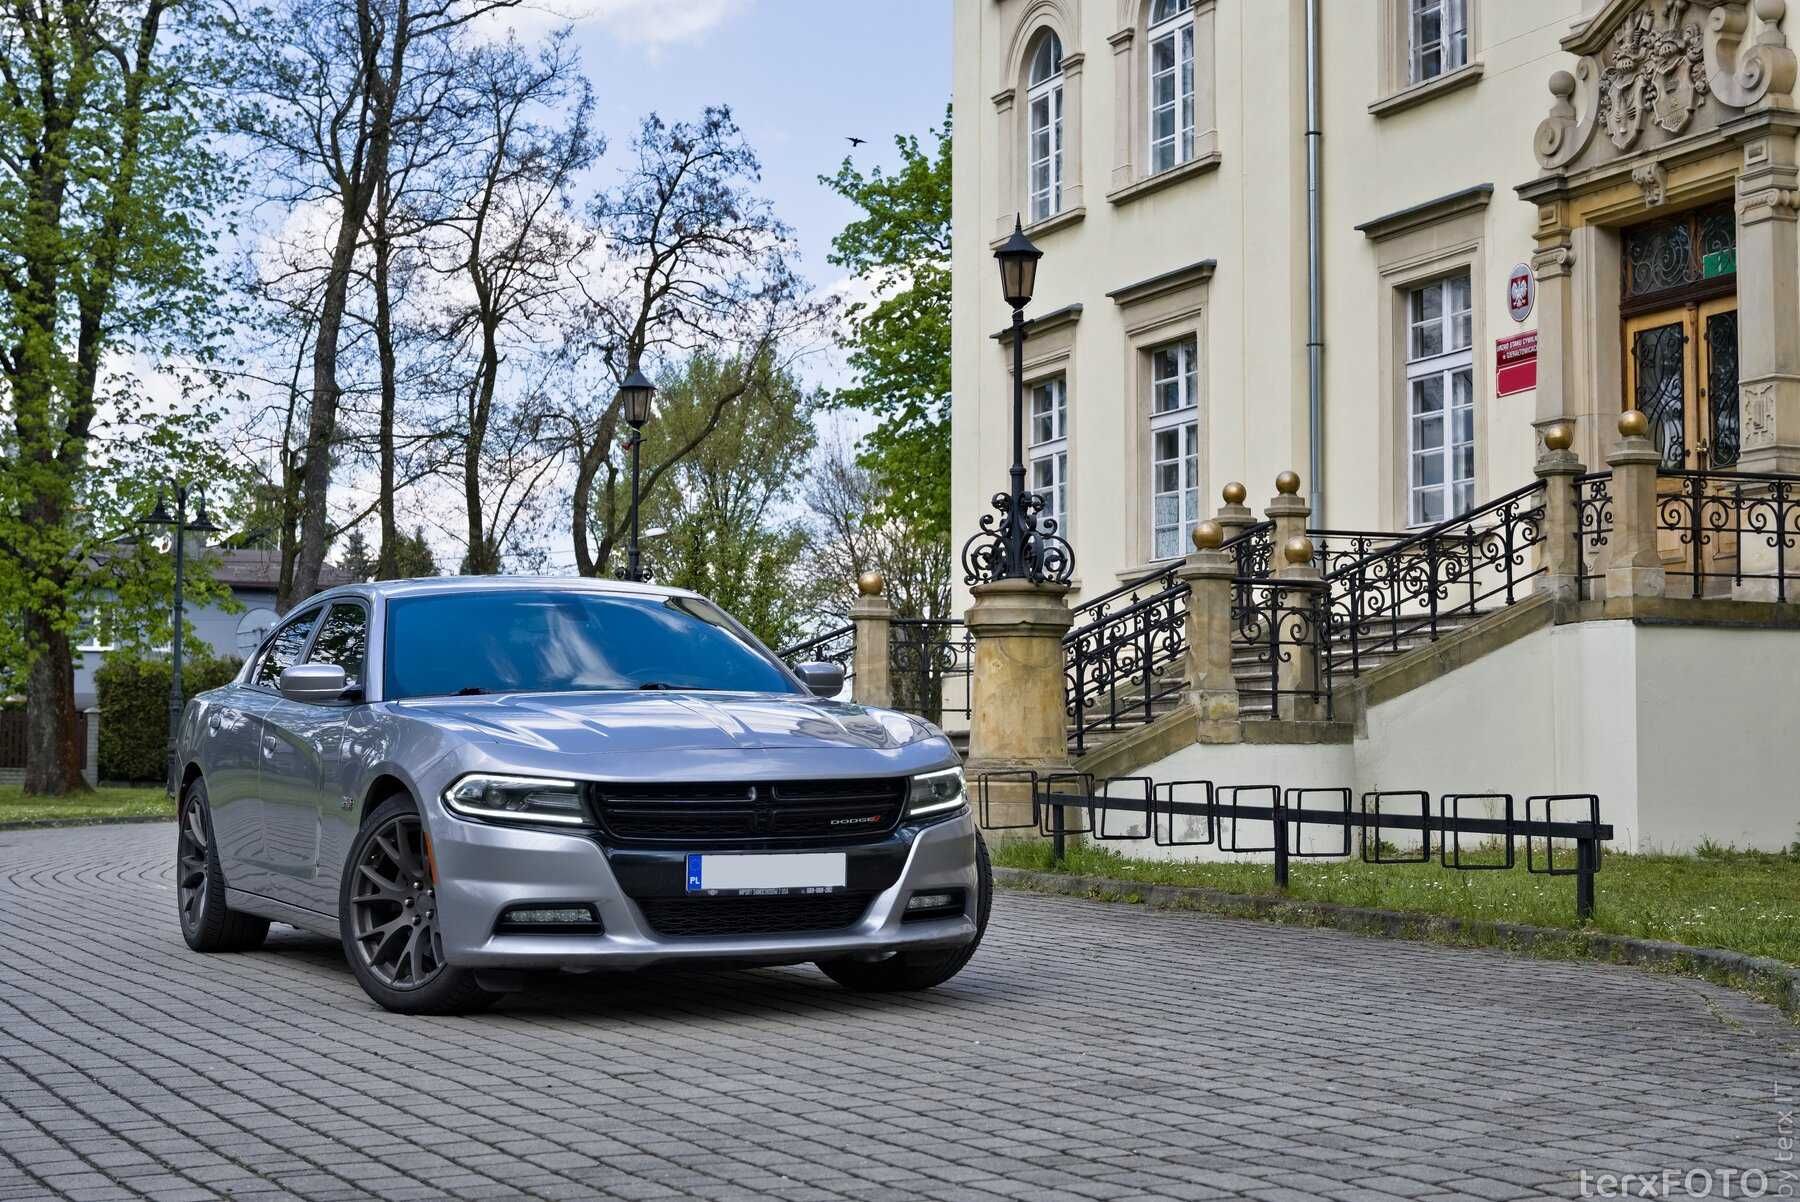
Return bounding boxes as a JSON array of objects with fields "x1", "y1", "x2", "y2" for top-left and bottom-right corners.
[{"x1": 1231, "y1": 578, "x2": 1332, "y2": 718}]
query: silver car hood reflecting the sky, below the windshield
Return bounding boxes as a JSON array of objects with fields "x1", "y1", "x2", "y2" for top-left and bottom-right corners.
[{"x1": 392, "y1": 691, "x2": 941, "y2": 756}]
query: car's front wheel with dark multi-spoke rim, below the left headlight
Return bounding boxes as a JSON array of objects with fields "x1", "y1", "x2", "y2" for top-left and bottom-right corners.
[{"x1": 338, "y1": 797, "x2": 500, "y2": 1015}]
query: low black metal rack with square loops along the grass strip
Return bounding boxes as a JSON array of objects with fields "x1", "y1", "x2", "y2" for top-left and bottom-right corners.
[{"x1": 976, "y1": 770, "x2": 1613, "y2": 921}]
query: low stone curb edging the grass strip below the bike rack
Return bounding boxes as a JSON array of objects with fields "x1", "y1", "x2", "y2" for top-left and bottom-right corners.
[{"x1": 994, "y1": 867, "x2": 1800, "y2": 1020}]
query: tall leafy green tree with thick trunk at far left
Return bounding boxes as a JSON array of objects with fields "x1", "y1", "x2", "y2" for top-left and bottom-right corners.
[{"x1": 0, "y1": 0, "x2": 229, "y2": 795}]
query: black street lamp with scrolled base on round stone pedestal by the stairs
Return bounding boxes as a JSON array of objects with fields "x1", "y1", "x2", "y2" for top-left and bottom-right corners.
[{"x1": 963, "y1": 218, "x2": 1075, "y2": 585}]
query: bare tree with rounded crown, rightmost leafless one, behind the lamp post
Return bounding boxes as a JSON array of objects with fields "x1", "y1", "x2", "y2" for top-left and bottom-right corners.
[{"x1": 562, "y1": 108, "x2": 821, "y2": 576}]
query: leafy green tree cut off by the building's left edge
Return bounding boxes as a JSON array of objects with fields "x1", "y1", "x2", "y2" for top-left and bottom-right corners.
[{"x1": 819, "y1": 110, "x2": 950, "y2": 538}]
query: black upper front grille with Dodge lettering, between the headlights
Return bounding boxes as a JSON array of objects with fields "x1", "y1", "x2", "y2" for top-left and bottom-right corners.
[{"x1": 592, "y1": 777, "x2": 905, "y2": 848}]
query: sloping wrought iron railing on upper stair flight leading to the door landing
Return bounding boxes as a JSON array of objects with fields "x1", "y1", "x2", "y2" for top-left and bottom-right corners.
[{"x1": 1325, "y1": 480, "x2": 1544, "y2": 675}]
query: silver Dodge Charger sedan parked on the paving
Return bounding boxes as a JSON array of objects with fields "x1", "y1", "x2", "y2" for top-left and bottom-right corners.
[{"x1": 176, "y1": 578, "x2": 992, "y2": 1013}]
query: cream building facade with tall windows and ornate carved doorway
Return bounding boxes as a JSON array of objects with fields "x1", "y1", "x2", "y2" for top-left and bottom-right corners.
[{"x1": 952, "y1": 0, "x2": 1800, "y2": 603}]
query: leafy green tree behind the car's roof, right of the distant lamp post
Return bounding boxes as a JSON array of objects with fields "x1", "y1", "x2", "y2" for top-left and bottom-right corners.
[{"x1": 640, "y1": 351, "x2": 819, "y2": 646}]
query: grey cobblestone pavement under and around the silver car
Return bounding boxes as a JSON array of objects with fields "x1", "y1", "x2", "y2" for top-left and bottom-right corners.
[{"x1": 0, "y1": 824, "x2": 1800, "y2": 1202}]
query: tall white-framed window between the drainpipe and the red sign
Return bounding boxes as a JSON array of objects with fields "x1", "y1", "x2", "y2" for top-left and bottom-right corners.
[{"x1": 1402, "y1": 278, "x2": 1478, "y2": 529}]
